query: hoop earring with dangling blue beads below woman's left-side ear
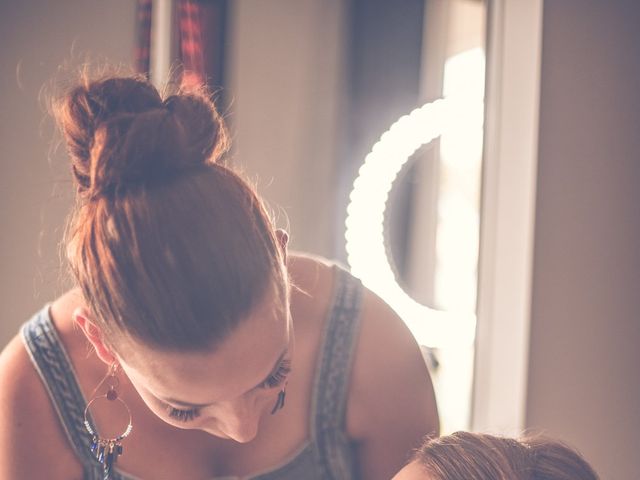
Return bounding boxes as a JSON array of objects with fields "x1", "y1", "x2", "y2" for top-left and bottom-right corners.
[{"x1": 84, "y1": 362, "x2": 133, "y2": 480}]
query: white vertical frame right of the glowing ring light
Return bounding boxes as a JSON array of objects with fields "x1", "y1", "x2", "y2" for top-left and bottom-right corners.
[{"x1": 471, "y1": 0, "x2": 543, "y2": 435}]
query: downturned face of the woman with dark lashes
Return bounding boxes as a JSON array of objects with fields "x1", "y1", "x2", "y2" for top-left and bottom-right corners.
[{"x1": 115, "y1": 282, "x2": 294, "y2": 442}]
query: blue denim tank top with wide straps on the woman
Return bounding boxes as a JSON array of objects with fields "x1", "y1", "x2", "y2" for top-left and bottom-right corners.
[{"x1": 21, "y1": 266, "x2": 362, "y2": 480}]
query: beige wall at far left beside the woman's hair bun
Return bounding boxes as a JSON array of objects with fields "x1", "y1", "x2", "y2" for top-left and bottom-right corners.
[{"x1": 0, "y1": 0, "x2": 135, "y2": 348}]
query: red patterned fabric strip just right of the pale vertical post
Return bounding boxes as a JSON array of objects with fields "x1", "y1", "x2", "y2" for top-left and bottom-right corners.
[{"x1": 178, "y1": 0, "x2": 205, "y2": 86}]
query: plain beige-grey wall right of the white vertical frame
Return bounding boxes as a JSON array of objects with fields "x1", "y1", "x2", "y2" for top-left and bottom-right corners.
[{"x1": 527, "y1": 0, "x2": 640, "y2": 480}]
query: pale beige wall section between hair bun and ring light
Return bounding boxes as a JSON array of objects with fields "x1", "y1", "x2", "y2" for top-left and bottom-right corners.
[{"x1": 226, "y1": 0, "x2": 346, "y2": 255}]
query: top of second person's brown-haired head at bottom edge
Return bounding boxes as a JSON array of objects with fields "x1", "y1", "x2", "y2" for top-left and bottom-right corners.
[{"x1": 394, "y1": 432, "x2": 598, "y2": 480}]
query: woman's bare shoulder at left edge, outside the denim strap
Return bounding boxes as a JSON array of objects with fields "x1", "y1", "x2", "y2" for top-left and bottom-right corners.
[{"x1": 0, "y1": 316, "x2": 82, "y2": 479}]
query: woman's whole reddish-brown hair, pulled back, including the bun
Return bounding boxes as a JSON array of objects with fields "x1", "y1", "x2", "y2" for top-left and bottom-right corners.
[{"x1": 56, "y1": 77, "x2": 287, "y2": 350}]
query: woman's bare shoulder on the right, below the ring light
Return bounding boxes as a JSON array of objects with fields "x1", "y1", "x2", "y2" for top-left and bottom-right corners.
[{"x1": 347, "y1": 278, "x2": 439, "y2": 479}]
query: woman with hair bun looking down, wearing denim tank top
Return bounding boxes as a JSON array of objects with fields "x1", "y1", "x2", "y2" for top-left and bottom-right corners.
[{"x1": 0, "y1": 77, "x2": 438, "y2": 480}]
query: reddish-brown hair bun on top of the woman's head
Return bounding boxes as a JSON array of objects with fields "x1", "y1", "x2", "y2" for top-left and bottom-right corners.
[{"x1": 58, "y1": 77, "x2": 227, "y2": 198}]
